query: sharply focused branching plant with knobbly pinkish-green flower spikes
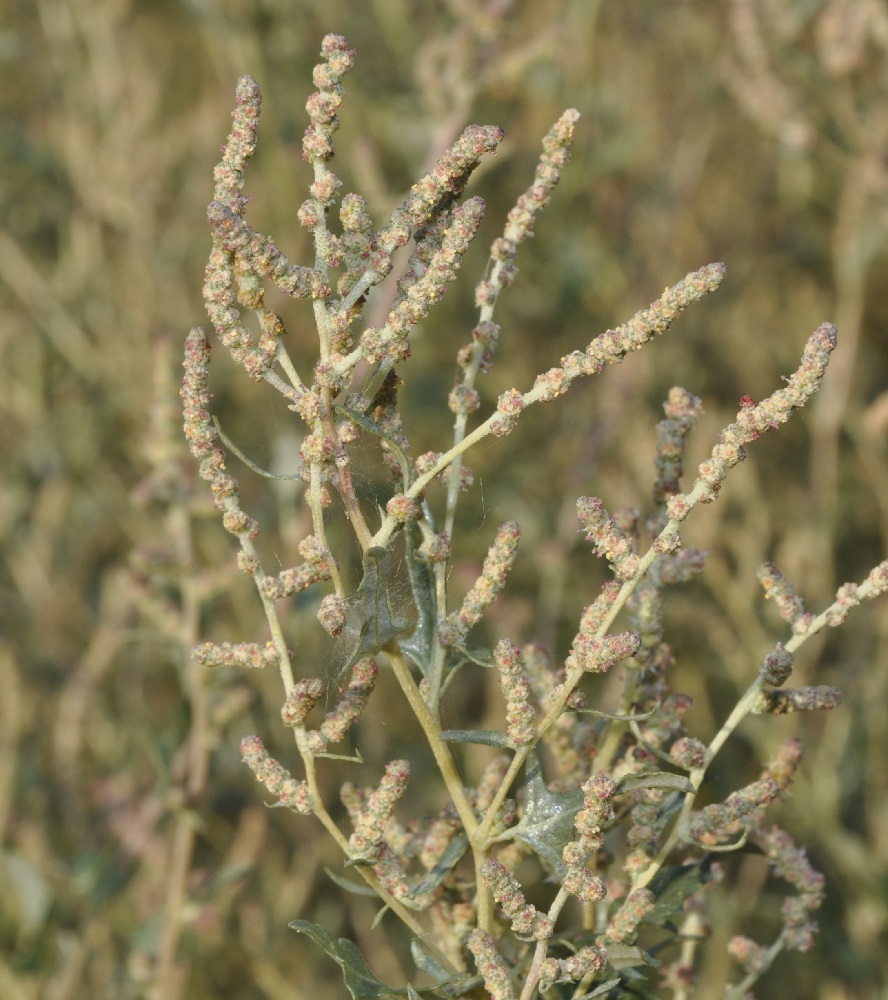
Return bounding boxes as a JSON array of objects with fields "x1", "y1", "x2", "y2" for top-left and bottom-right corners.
[{"x1": 182, "y1": 35, "x2": 888, "y2": 1000}]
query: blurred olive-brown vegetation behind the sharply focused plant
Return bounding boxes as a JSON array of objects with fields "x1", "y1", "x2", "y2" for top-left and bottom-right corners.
[{"x1": 0, "y1": 0, "x2": 888, "y2": 1000}]
